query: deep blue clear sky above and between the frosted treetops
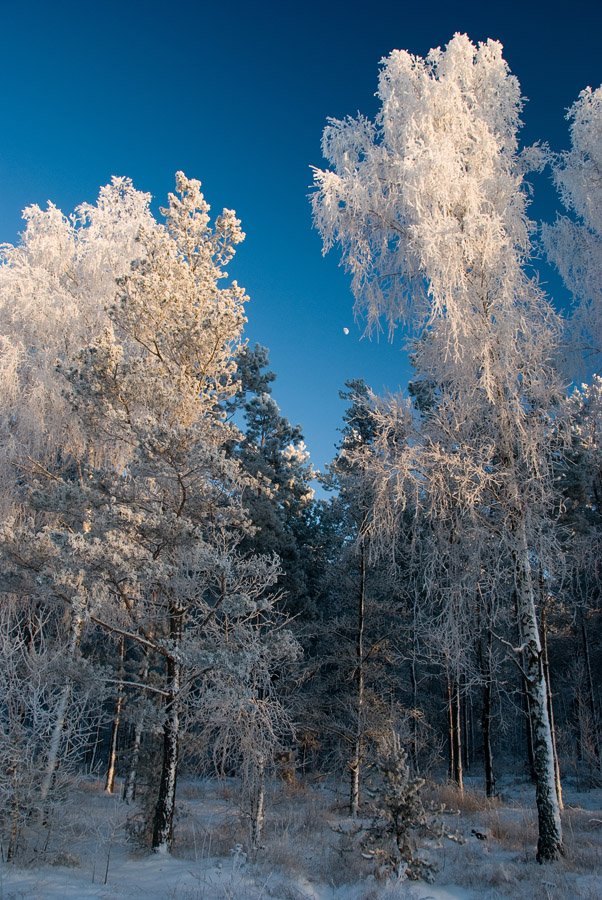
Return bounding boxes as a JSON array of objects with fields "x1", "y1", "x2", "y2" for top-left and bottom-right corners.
[{"x1": 0, "y1": 0, "x2": 602, "y2": 478}]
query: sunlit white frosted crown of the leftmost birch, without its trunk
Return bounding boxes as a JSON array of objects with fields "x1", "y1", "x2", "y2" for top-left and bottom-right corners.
[{"x1": 0, "y1": 178, "x2": 154, "y2": 492}]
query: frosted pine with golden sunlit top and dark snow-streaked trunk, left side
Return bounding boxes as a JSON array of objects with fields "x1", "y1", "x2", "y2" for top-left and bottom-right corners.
[{"x1": 3, "y1": 173, "x2": 295, "y2": 851}]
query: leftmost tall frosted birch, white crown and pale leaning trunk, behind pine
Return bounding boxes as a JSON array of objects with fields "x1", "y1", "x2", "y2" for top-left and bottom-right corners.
[{"x1": 0, "y1": 178, "x2": 154, "y2": 828}]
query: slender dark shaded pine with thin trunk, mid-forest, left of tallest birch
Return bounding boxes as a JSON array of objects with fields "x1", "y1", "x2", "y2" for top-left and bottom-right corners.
[{"x1": 320, "y1": 379, "x2": 397, "y2": 817}]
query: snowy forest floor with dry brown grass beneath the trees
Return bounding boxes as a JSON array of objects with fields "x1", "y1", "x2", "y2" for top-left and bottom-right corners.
[{"x1": 0, "y1": 779, "x2": 602, "y2": 900}]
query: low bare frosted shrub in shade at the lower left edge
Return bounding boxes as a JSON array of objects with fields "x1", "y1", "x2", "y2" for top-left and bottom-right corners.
[{"x1": 0, "y1": 597, "x2": 102, "y2": 860}]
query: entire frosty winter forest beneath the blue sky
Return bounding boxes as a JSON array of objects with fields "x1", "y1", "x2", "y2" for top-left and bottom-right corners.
[{"x1": 0, "y1": 34, "x2": 602, "y2": 900}]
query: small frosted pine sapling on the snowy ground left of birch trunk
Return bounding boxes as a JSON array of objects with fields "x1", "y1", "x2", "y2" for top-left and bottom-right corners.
[{"x1": 363, "y1": 732, "x2": 442, "y2": 882}]
